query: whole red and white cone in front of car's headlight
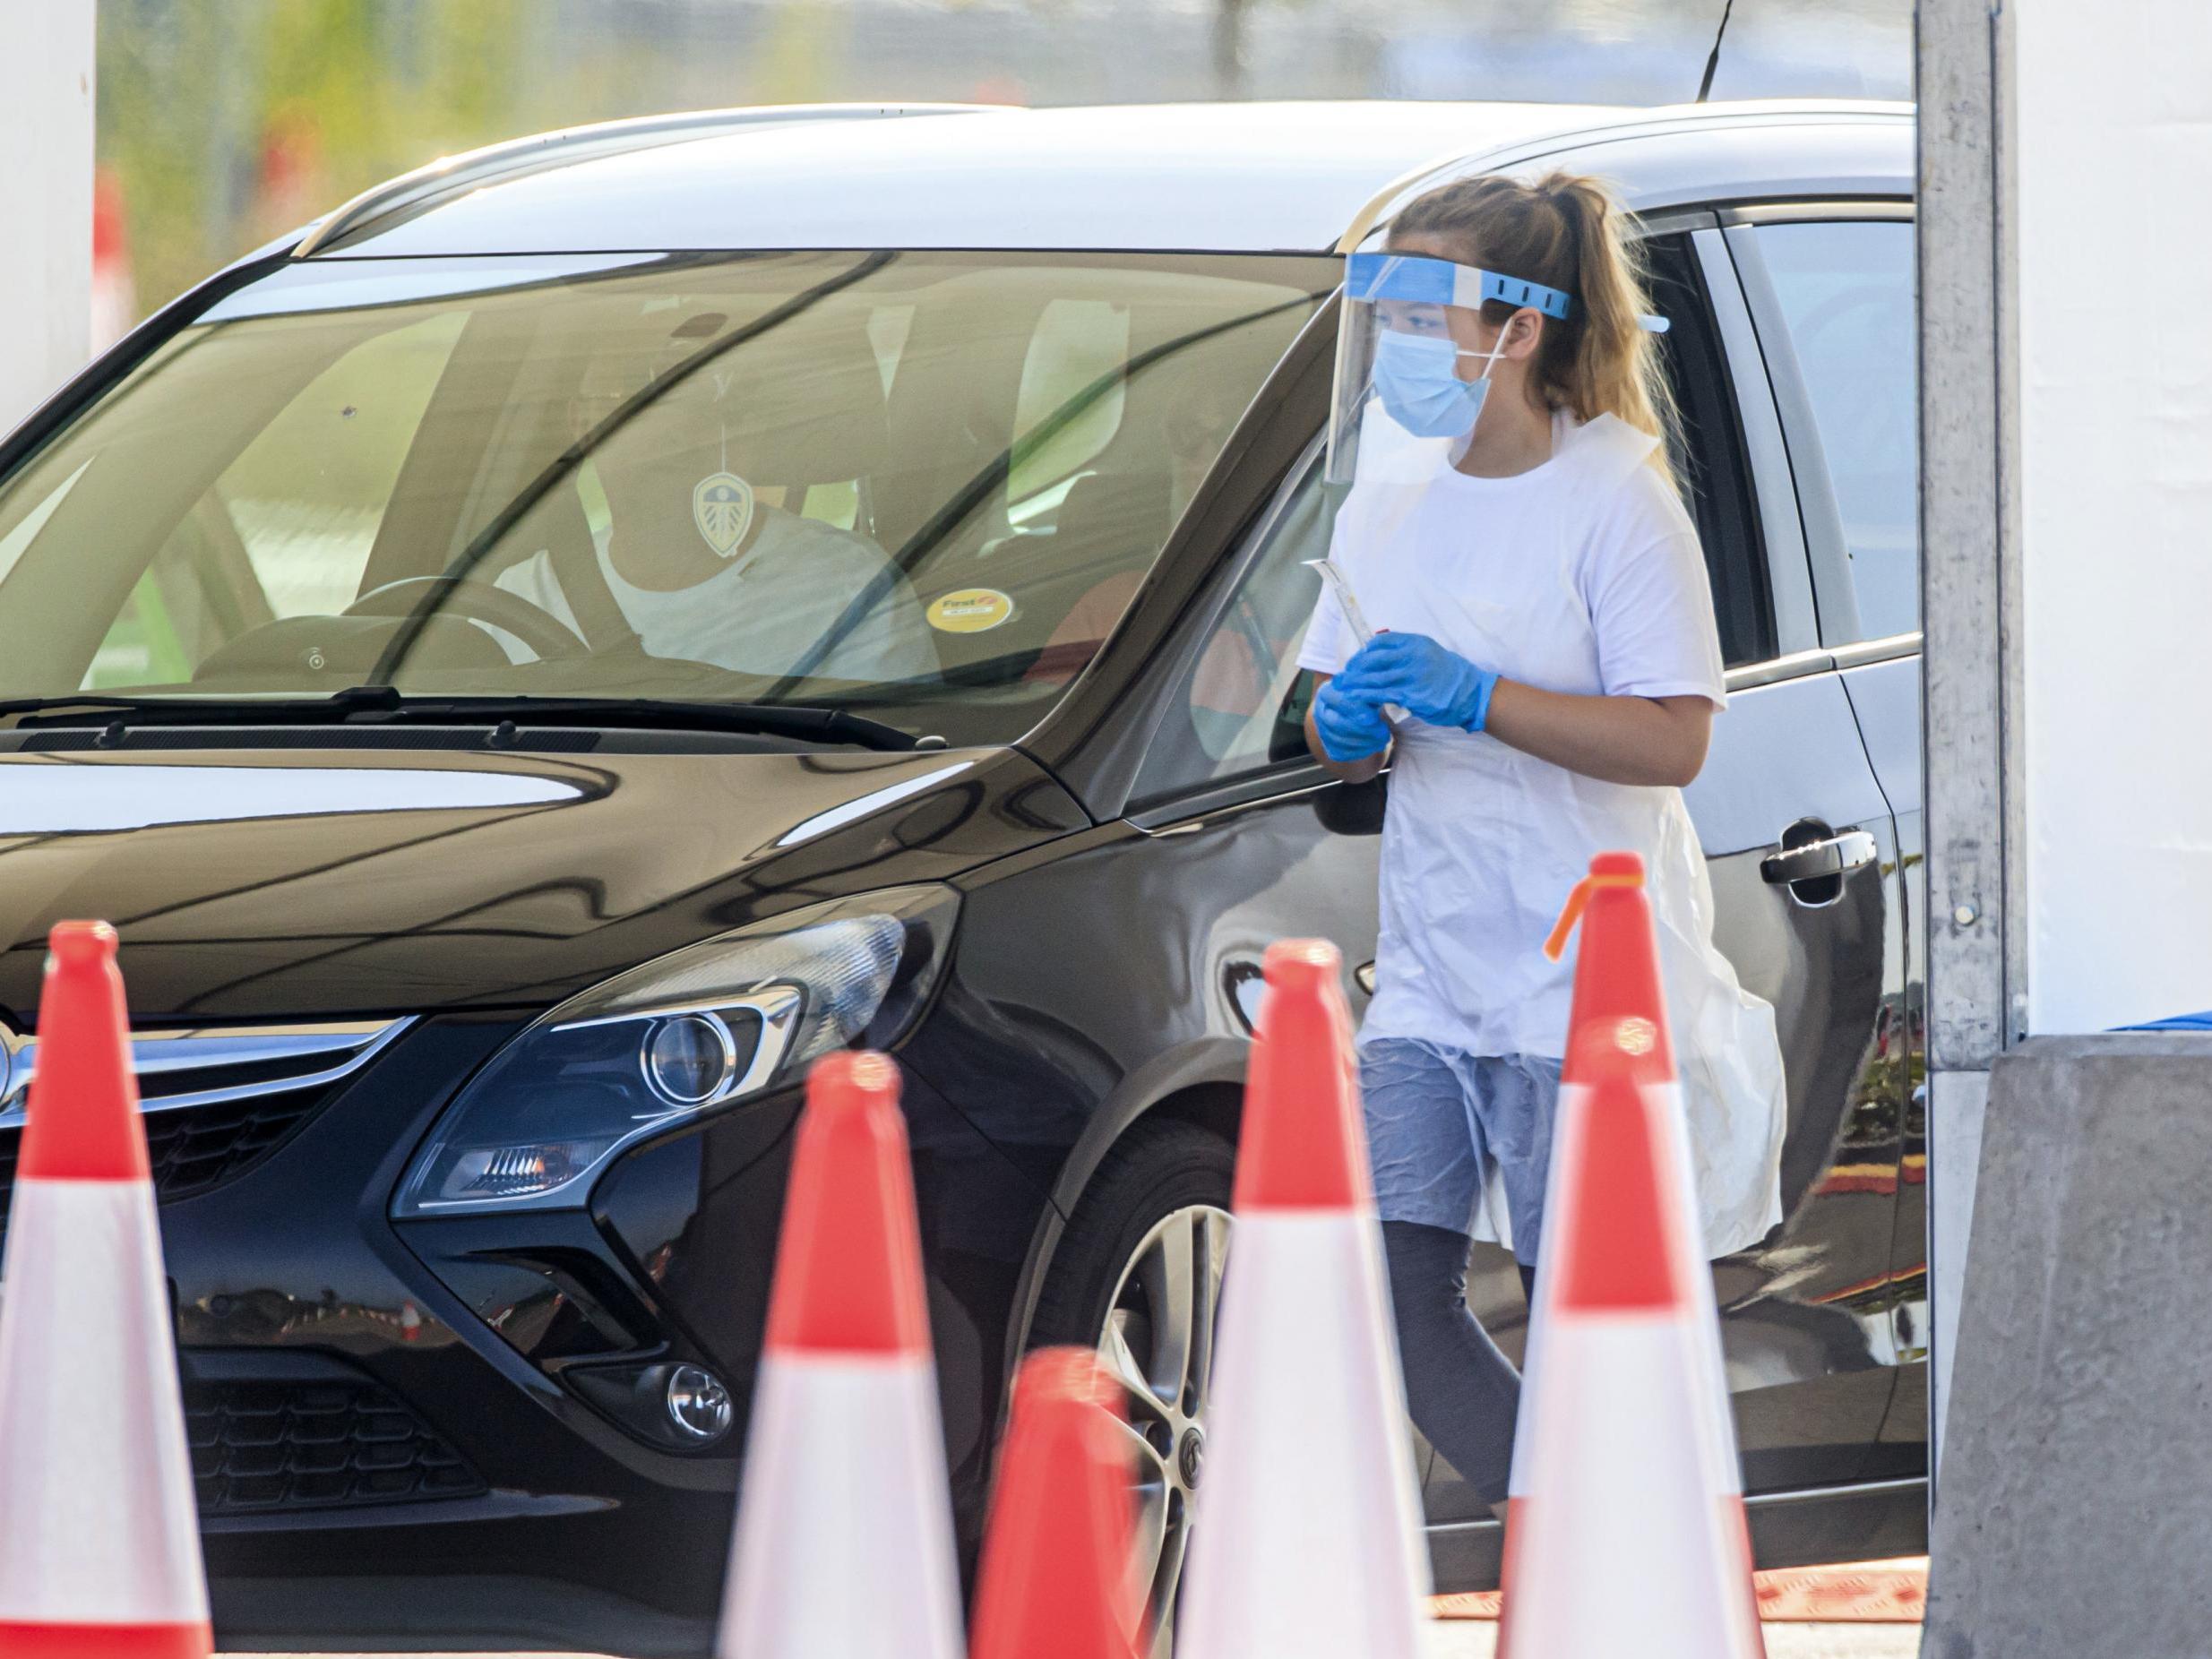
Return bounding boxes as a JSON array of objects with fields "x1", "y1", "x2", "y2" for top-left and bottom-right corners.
[{"x1": 721, "y1": 1053, "x2": 960, "y2": 1659}]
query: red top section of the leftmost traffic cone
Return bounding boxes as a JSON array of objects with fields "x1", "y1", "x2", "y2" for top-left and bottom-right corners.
[{"x1": 15, "y1": 923, "x2": 151, "y2": 1182}]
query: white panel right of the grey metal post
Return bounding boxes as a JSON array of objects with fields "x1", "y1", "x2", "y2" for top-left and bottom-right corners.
[{"x1": 2010, "y1": 0, "x2": 2212, "y2": 1036}]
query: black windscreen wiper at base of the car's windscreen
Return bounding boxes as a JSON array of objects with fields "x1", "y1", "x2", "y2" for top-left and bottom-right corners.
[{"x1": 0, "y1": 685, "x2": 925, "y2": 750}]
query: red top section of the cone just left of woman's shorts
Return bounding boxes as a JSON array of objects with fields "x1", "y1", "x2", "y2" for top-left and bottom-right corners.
[{"x1": 1236, "y1": 940, "x2": 1372, "y2": 1212}]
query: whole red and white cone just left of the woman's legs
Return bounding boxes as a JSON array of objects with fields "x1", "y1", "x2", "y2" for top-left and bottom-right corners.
[{"x1": 1177, "y1": 940, "x2": 1429, "y2": 1659}]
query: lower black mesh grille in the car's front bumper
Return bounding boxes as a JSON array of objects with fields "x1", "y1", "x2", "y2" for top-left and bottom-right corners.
[{"x1": 184, "y1": 1373, "x2": 489, "y2": 1517}]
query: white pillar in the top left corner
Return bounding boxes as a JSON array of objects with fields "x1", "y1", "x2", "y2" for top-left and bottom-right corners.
[{"x1": 0, "y1": 0, "x2": 93, "y2": 432}]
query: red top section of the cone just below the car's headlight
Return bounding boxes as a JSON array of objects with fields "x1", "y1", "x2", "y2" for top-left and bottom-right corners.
[{"x1": 768, "y1": 1053, "x2": 929, "y2": 1354}]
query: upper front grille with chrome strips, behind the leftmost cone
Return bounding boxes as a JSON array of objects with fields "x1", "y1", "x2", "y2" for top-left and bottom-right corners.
[{"x1": 0, "y1": 1019, "x2": 409, "y2": 1236}]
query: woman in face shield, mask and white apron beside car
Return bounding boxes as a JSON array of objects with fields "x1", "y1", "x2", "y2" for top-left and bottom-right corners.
[{"x1": 1298, "y1": 175, "x2": 1785, "y2": 1513}]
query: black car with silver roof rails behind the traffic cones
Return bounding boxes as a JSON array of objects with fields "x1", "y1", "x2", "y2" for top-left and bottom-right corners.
[{"x1": 0, "y1": 104, "x2": 1929, "y2": 1653}]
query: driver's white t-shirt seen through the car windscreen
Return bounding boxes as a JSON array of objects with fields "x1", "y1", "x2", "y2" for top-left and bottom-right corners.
[{"x1": 494, "y1": 506, "x2": 938, "y2": 682}]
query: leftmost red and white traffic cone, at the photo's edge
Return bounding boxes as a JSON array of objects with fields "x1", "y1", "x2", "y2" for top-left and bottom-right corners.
[{"x1": 0, "y1": 923, "x2": 212, "y2": 1659}]
